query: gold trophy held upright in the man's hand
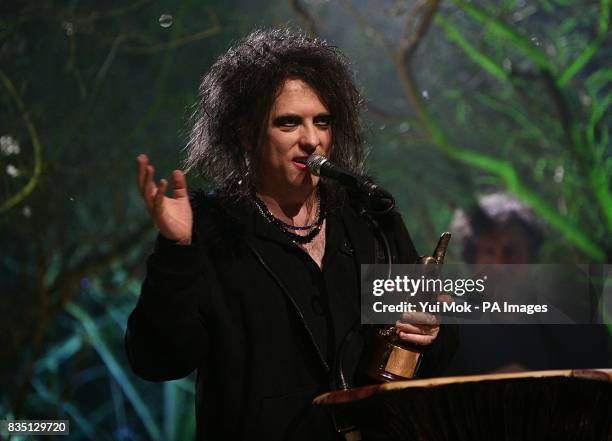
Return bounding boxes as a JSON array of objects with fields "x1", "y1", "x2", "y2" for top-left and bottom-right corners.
[{"x1": 367, "y1": 232, "x2": 451, "y2": 382}]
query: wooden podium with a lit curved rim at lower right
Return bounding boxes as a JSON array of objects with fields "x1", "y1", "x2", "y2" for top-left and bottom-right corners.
[{"x1": 313, "y1": 369, "x2": 612, "y2": 441}]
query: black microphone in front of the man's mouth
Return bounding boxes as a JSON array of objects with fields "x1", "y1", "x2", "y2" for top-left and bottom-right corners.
[{"x1": 306, "y1": 155, "x2": 395, "y2": 208}]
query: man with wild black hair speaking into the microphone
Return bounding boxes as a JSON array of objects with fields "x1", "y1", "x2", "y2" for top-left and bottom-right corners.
[{"x1": 126, "y1": 30, "x2": 454, "y2": 440}]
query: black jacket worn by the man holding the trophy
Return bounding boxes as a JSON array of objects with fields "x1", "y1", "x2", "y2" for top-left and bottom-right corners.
[{"x1": 126, "y1": 192, "x2": 453, "y2": 441}]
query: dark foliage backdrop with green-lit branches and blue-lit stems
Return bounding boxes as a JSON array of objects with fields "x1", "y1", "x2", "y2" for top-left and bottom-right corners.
[{"x1": 0, "y1": 0, "x2": 612, "y2": 440}]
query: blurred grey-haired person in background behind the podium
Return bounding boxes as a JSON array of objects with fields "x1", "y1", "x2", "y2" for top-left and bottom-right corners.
[{"x1": 446, "y1": 193, "x2": 612, "y2": 375}]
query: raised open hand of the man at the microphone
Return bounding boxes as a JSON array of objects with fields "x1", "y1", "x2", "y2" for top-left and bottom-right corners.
[{"x1": 136, "y1": 155, "x2": 193, "y2": 245}]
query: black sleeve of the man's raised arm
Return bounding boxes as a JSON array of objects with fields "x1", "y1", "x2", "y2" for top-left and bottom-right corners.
[{"x1": 125, "y1": 230, "x2": 213, "y2": 381}]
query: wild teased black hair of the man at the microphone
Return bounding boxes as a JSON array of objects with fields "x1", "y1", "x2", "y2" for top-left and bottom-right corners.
[{"x1": 186, "y1": 30, "x2": 363, "y2": 196}]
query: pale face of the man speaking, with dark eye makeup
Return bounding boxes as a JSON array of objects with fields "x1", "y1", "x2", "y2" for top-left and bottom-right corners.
[{"x1": 258, "y1": 80, "x2": 332, "y2": 194}]
